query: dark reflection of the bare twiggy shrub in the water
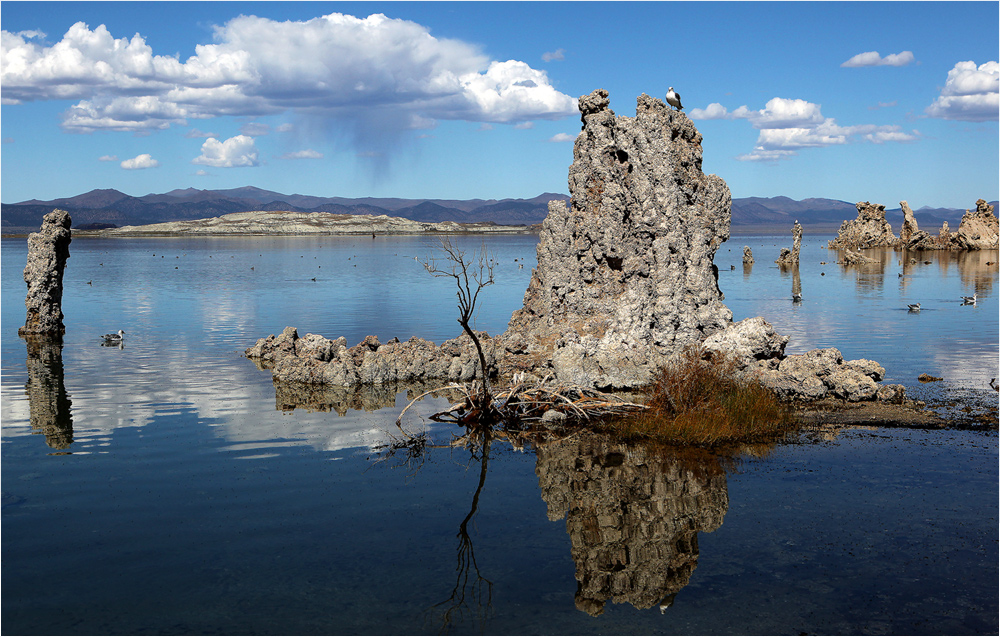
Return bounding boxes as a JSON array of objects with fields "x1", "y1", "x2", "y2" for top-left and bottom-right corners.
[{"x1": 431, "y1": 433, "x2": 493, "y2": 632}]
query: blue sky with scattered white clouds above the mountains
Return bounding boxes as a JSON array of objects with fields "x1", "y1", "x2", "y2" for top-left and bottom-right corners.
[{"x1": 0, "y1": 1, "x2": 1000, "y2": 208}]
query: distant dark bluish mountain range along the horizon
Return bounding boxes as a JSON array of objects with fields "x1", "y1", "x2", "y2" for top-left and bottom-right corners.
[{"x1": 0, "y1": 186, "x2": 996, "y2": 233}]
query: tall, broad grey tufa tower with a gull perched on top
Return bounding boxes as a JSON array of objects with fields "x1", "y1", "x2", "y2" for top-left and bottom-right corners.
[{"x1": 500, "y1": 90, "x2": 732, "y2": 388}]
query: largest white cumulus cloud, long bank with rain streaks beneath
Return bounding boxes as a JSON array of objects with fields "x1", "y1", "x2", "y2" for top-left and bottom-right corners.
[{"x1": 0, "y1": 13, "x2": 577, "y2": 139}]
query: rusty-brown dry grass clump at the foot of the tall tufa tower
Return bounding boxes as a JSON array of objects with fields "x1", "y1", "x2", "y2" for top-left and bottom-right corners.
[{"x1": 605, "y1": 347, "x2": 793, "y2": 447}]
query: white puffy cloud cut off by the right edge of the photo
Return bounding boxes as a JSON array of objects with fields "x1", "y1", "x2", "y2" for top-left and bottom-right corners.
[{"x1": 924, "y1": 61, "x2": 1000, "y2": 122}]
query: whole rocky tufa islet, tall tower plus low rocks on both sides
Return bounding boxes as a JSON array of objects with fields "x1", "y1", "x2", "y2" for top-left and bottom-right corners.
[{"x1": 246, "y1": 90, "x2": 905, "y2": 404}]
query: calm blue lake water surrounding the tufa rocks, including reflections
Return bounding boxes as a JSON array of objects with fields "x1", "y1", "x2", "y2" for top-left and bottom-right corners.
[{"x1": 0, "y1": 235, "x2": 1000, "y2": 635}]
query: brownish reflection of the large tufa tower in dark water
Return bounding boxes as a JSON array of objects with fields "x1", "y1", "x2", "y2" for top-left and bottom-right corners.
[{"x1": 535, "y1": 436, "x2": 729, "y2": 616}]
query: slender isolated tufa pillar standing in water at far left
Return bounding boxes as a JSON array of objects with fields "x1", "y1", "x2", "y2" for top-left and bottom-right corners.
[{"x1": 17, "y1": 209, "x2": 73, "y2": 336}]
